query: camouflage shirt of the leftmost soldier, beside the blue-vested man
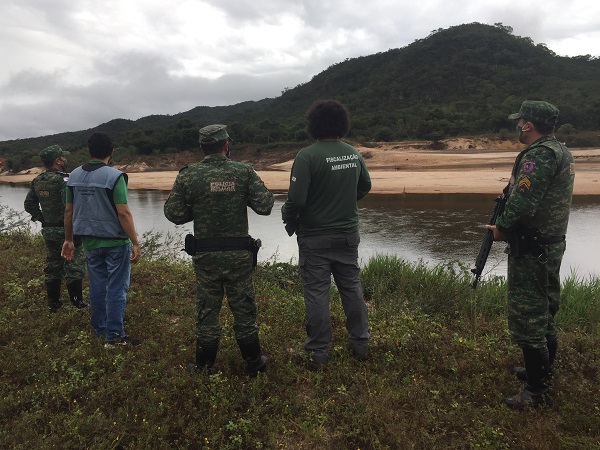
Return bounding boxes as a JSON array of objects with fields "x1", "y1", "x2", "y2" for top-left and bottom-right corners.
[{"x1": 23, "y1": 168, "x2": 69, "y2": 240}]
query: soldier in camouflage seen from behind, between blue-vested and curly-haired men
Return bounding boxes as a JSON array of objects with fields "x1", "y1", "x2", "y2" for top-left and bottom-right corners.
[{"x1": 164, "y1": 125, "x2": 274, "y2": 376}]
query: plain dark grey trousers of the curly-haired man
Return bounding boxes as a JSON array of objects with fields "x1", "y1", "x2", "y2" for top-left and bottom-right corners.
[{"x1": 298, "y1": 232, "x2": 369, "y2": 363}]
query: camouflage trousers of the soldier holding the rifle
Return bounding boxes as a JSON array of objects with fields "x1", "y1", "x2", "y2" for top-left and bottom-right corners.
[{"x1": 507, "y1": 242, "x2": 566, "y2": 348}]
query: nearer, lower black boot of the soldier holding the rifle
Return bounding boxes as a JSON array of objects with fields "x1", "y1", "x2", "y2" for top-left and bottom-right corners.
[{"x1": 504, "y1": 347, "x2": 552, "y2": 409}]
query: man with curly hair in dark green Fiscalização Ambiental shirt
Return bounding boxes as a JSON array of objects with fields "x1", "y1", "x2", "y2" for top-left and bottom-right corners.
[{"x1": 281, "y1": 100, "x2": 371, "y2": 369}]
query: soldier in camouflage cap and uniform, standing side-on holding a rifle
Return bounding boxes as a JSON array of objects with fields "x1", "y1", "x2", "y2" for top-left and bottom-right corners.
[{"x1": 487, "y1": 100, "x2": 575, "y2": 409}]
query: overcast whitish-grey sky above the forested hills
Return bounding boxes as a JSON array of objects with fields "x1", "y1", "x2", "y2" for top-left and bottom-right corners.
[{"x1": 0, "y1": 0, "x2": 600, "y2": 140}]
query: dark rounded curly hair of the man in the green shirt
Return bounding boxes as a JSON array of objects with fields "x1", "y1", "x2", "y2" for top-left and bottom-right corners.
[{"x1": 306, "y1": 100, "x2": 350, "y2": 139}]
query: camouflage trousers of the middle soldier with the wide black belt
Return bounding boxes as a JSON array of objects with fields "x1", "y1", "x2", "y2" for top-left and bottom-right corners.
[{"x1": 194, "y1": 250, "x2": 258, "y2": 344}]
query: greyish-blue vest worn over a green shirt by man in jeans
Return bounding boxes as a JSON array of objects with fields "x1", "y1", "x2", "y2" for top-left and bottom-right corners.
[{"x1": 68, "y1": 164, "x2": 127, "y2": 239}]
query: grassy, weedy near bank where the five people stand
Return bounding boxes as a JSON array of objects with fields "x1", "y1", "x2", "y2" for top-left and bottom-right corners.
[{"x1": 0, "y1": 233, "x2": 600, "y2": 449}]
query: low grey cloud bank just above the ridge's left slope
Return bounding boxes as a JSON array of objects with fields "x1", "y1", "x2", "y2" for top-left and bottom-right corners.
[{"x1": 0, "y1": 53, "x2": 305, "y2": 139}]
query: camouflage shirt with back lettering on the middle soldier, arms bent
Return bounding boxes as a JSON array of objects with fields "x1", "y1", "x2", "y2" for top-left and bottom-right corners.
[{"x1": 164, "y1": 154, "x2": 274, "y2": 239}]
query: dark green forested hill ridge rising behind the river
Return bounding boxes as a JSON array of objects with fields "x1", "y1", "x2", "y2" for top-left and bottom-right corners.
[{"x1": 0, "y1": 23, "x2": 600, "y2": 169}]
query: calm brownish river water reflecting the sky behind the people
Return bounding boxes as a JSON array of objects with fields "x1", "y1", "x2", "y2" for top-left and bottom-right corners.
[{"x1": 0, "y1": 183, "x2": 600, "y2": 277}]
